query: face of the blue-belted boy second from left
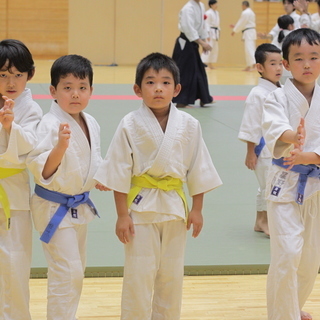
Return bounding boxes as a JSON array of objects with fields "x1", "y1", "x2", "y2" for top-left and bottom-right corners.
[{"x1": 50, "y1": 74, "x2": 93, "y2": 117}]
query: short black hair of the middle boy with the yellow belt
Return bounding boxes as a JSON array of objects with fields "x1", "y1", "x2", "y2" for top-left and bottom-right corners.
[{"x1": 135, "y1": 52, "x2": 180, "y2": 87}]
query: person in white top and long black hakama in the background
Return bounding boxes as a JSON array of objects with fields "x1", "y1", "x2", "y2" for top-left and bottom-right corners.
[{"x1": 172, "y1": 0, "x2": 213, "y2": 108}]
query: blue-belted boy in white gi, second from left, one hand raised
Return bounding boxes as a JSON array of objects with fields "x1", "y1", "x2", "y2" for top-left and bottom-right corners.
[{"x1": 27, "y1": 55, "x2": 102, "y2": 320}]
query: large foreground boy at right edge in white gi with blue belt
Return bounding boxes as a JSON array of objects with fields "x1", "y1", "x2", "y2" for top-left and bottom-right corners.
[{"x1": 262, "y1": 28, "x2": 320, "y2": 320}]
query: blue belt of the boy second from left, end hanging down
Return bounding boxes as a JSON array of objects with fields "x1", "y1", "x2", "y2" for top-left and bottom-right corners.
[{"x1": 34, "y1": 185, "x2": 99, "y2": 243}]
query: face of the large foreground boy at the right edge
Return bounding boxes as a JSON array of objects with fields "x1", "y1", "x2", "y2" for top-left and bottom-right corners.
[{"x1": 283, "y1": 40, "x2": 320, "y2": 85}]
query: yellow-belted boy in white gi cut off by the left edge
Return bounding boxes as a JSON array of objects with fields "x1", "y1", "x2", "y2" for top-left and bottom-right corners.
[{"x1": 0, "y1": 39, "x2": 42, "y2": 320}]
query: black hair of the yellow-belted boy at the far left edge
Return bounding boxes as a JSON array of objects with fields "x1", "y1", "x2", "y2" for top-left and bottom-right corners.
[{"x1": 0, "y1": 39, "x2": 35, "y2": 79}]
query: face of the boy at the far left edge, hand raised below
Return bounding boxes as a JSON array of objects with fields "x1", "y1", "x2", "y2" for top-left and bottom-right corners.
[{"x1": 0, "y1": 65, "x2": 28, "y2": 99}]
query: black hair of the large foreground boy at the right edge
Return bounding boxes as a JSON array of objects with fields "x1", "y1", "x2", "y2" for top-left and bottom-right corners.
[{"x1": 282, "y1": 28, "x2": 320, "y2": 60}]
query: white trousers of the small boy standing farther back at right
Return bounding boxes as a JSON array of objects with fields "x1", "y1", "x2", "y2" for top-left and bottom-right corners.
[{"x1": 254, "y1": 157, "x2": 271, "y2": 211}]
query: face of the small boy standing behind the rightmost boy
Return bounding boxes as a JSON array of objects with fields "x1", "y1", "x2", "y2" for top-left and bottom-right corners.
[{"x1": 257, "y1": 52, "x2": 283, "y2": 84}]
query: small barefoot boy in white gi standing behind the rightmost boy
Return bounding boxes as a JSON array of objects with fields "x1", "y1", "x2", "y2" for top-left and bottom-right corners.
[{"x1": 238, "y1": 43, "x2": 283, "y2": 235}]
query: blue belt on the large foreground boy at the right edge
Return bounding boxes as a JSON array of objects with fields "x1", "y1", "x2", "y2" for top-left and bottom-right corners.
[{"x1": 272, "y1": 158, "x2": 320, "y2": 204}]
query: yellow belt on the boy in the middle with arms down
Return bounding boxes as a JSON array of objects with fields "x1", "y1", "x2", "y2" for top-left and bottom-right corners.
[{"x1": 127, "y1": 174, "x2": 188, "y2": 215}]
